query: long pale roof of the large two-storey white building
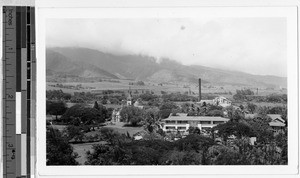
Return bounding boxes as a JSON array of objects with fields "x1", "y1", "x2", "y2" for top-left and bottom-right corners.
[{"x1": 164, "y1": 115, "x2": 230, "y2": 122}]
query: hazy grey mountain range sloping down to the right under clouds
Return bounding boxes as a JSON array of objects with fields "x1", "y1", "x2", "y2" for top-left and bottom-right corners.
[{"x1": 46, "y1": 47, "x2": 287, "y2": 87}]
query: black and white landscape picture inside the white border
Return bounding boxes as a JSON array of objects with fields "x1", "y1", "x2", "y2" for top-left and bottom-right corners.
[{"x1": 45, "y1": 17, "x2": 289, "y2": 166}]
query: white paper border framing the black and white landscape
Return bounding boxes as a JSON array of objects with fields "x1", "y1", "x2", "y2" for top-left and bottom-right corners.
[{"x1": 36, "y1": 0, "x2": 299, "y2": 177}]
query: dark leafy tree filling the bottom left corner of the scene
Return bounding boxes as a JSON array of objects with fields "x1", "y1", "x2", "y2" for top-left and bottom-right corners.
[{"x1": 46, "y1": 127, "x2": 78, "y2": 166}]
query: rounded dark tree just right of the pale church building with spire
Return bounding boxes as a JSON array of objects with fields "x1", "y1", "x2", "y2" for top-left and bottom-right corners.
[{"x1": 120, "y1": 106, "x2": 144, "y2": 126}]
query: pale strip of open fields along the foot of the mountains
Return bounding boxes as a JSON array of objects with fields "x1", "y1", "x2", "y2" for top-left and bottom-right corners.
[{"x1": 47, "y1": 80, "x2": 287, "y2": 98}]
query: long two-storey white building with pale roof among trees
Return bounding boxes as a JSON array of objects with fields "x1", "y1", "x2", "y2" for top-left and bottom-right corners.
[{"x1": 163, "y1": 113, "x2": 229, "y2": 132}]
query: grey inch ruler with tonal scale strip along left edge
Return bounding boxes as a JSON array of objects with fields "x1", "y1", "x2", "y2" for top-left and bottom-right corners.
[{"x1": 2, "y1": 6, "x2": 36, "y2": 178}]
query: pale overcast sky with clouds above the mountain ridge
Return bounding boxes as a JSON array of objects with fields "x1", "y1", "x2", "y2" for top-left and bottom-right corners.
[{"x1": 46, "y1": 17, "x2": 287, "y2": 77}]
